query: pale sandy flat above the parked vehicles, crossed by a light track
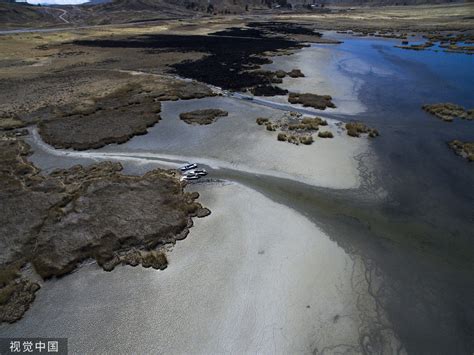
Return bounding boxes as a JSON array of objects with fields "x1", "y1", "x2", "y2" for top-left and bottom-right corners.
[{"x1": 30, "y1": 97, "x2": 369, "y2": 189}]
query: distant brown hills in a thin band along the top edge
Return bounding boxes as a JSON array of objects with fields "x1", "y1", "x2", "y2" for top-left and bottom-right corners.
[{"x1": 0, "y1": 0, "x2": 471, "y2": 29}]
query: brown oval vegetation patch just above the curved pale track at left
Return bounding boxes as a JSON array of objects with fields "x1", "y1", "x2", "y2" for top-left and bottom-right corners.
[{"x1": 37, "y1": 80, "x2": 213, "y2": 150}]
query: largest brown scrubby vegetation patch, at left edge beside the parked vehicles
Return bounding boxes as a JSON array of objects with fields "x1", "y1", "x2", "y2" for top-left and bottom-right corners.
[{"x1": 0, "y1": 135, "x2": 209, "y2": 323}]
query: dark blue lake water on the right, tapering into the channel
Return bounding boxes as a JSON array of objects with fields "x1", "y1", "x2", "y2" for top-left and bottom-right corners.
[{"x1": 260, "y1": 38, "x2": 474, "y2": 354}]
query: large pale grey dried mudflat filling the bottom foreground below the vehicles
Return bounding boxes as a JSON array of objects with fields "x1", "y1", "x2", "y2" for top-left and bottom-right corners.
[{"x1": 0, "y1": 183, "x2": 400, "y2": 353}]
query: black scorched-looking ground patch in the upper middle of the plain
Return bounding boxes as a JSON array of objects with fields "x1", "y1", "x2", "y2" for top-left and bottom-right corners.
[{"x1": 74, "y1": 35, "x2": 301, "y2": 90}]
